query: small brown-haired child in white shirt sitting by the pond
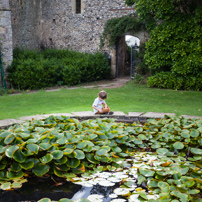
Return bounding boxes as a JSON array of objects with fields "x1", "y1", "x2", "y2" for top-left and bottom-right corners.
[{"x1": 92, "y1": 91, "x2": 113, "y2": 115}]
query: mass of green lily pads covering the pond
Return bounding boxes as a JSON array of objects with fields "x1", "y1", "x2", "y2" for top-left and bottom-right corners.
[{"x1": 0, "y1": 116, "x2": 202, "y2": 202}]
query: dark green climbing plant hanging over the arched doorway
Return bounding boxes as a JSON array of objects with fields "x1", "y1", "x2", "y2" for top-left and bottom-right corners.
[{"x1": 100, "y1": 15, "x2": 144, "y2": 47}]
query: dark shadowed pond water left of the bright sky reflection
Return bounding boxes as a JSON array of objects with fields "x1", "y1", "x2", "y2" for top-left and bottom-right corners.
[{"x1": 0, "y1": 177, "x2": 82, "y2": 202}]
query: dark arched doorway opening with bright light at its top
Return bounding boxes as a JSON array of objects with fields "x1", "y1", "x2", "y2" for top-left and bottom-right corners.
[{"x1": 116, "y1": 34, "x2": 140, "y2": 77}]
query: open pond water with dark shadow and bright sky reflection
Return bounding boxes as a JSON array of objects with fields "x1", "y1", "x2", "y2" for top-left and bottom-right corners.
[{"x1": 0, "y1": 177, "x2": 119, "y2": 202}]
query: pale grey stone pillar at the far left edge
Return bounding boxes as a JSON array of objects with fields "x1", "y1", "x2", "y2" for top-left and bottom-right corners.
[{"x1": 0, "y1": 0, "x2": 13, "y2": 69}]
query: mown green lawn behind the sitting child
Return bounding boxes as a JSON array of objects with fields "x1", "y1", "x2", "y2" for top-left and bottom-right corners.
[{"x1": 0, "y1": 81, "x2": 202, "y2": 120}]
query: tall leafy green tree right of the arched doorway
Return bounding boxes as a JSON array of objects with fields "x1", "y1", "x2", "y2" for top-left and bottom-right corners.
[{"x1": 126, "y1": 0, "x2": 202, "y2": 90}]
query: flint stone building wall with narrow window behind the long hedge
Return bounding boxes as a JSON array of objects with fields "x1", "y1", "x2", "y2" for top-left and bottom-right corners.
[{"x1": 0, "y1": 0, "x2": 148, "y2": 77}]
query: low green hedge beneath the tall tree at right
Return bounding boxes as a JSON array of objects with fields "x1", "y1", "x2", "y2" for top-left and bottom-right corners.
[{"x1": 147, "y1": 72, "x2": 202, "y2": 91}]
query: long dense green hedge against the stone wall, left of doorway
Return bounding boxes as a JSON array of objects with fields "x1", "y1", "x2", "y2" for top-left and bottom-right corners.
[{"x1": 7, "y1": 49, "x2": 110, "y2": 89}]
